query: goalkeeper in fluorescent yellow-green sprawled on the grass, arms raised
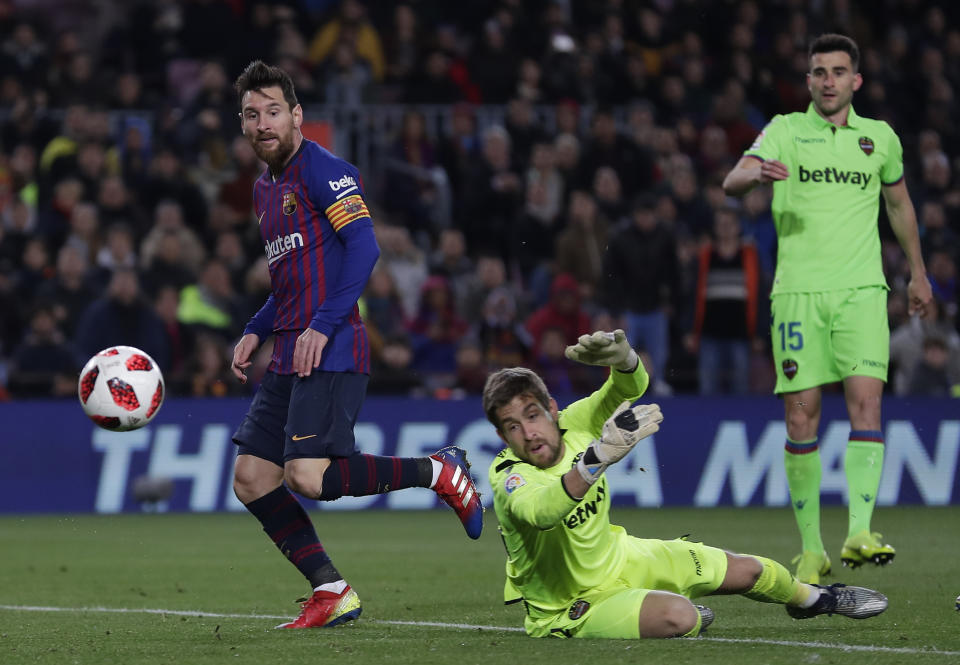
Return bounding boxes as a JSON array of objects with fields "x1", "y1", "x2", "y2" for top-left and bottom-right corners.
[{"x1": 483, "y1": 330, "x2": 887, "y2": 638}]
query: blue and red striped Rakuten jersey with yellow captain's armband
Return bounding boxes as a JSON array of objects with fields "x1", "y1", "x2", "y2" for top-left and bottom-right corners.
[{"x1": 244, "y1": 139, "x2": 380, "y2": 374}]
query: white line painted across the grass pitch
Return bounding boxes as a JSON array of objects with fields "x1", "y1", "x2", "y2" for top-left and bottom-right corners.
[{"x1": 0, "y1": 605, "x2": 960, "y2": 656}]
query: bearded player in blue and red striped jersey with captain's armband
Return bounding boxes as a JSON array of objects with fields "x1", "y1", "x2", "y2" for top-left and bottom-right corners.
[{"x1": 233, "y1": 61, "x2": 483, "y2": 628}]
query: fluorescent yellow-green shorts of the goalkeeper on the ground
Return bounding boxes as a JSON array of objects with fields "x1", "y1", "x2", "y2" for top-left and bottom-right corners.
[{"x1": 525, "y1": 537, "x2": 727, "y2": 640}]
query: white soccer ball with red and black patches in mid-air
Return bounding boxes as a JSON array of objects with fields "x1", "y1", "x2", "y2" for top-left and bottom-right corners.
[{"x1": 77, "y1": 346, "x2": 164, "y2": 432}]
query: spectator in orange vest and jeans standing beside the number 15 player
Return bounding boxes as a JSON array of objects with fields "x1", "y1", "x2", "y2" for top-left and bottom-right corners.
[{"x1": 685, "y1": 208, "x2": 760, "y2": 395}]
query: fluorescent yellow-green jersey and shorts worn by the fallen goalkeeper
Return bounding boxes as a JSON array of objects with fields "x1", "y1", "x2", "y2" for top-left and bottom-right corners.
[{"x1": 489, "y1": 363, "x2": 726, "y2": 638}]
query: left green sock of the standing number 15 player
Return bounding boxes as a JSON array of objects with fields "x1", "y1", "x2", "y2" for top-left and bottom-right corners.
[{"x1": 783, "y1": 438, "x2": 823, "y2": 554}]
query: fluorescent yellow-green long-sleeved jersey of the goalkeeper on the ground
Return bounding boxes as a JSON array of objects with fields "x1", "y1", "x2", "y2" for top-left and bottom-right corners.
[{"x1": 489, "y1": 363, "x2": 649, "y2": 612}]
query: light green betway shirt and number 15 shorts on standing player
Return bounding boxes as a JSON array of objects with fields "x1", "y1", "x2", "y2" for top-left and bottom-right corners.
[{"x1": 744, "y1": 103, "x2": 903, "y2": 393}]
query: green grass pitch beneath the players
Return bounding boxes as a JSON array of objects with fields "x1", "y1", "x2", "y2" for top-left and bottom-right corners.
[{"x1": 0, "y1": 507, "x2": 960, "y2": 665}]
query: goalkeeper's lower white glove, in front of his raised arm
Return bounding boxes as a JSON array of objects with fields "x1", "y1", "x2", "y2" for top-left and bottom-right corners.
[{"x1": 576, "y1": 402, "x2": 663, "y2": 485}]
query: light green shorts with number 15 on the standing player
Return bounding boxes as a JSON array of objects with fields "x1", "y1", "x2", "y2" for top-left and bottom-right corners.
[{"x1": 770, "y1": 286, "x2": 890, "y2": 394}]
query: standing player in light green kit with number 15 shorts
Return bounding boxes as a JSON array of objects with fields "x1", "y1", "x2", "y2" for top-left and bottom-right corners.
[{"x1": 723, "y1": 34, "x2": 932, "y2": 583}]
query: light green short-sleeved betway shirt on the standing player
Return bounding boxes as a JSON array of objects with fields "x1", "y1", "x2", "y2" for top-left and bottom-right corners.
[{"x1": 744, "y1": 103, "x2": 903, "y2": 295}]
